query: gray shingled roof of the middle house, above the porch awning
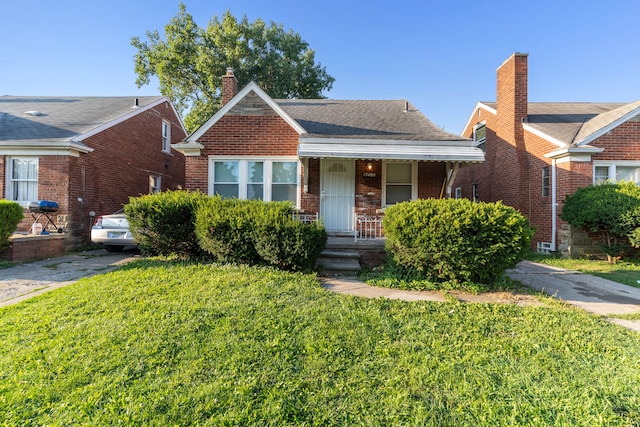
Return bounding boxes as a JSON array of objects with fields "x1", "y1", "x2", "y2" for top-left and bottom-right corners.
[{"x1": 275, "y1": 99, "x2": 466, "y2": 141}]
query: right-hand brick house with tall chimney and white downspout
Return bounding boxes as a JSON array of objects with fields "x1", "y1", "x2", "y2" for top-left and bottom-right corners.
[{"x1": 455, "y1": 53, "x2": 640, "y2": 255}]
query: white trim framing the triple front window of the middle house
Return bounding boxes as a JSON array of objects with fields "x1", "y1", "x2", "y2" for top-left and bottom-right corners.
[{"x1": 207, "y1": 156, "x2": 301, "y2": 209}]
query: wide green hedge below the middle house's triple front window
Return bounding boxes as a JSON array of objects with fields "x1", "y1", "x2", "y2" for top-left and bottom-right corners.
[{"x1": 196, "y1": 197, "x2": 327, "y2": 270}]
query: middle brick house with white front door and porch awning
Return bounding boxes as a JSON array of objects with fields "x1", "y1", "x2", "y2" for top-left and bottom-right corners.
[{"x1": 173, "y1": 70, "x2": 484, "y2": 237}]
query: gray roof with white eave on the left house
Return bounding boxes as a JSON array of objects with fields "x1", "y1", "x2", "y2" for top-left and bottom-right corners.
[{"x1": 0, "y1": 96, "x2": 175, "y2": 155}]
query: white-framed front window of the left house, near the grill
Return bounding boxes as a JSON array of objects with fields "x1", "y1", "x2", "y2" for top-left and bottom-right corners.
[{"x1": 6, "y1": 157, "x2": 38, "y2": 205}]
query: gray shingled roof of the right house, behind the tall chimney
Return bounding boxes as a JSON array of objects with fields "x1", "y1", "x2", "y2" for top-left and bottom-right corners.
[{"x1": 483, "y1": 101, "x2": 640, "y2": 146}]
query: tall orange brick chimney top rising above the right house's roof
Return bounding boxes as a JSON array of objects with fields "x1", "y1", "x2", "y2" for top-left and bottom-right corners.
[{"x1": 496, "y1": 52, "x2": 529, "y2": 138}]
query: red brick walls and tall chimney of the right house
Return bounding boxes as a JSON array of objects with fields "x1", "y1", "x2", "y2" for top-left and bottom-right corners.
[{"x1": 455, "y1": 54, "x2": 640, "y2": 254}]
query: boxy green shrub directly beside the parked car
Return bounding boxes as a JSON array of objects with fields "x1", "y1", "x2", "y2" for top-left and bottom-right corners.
[{"x1": 124, "y1": 190, "x2": 206, "y2": 258}]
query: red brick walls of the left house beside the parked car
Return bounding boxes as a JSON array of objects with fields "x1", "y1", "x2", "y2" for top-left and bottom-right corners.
[{"x1": 0, "y1": 102, "x2": 186, "y2": 249}]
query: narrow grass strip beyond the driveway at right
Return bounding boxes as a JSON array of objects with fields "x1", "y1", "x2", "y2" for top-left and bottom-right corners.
[{"x1": 527, "y1": 254, "x2": 640, "y2": 288}]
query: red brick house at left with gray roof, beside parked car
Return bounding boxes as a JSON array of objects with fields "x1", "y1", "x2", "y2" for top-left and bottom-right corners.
[{"x1": 0, "y1": 96, "x2": 186, "y2": 260}]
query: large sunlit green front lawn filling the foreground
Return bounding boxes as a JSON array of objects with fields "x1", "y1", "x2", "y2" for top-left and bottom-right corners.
[{"x1": 0, "y1": 260, "x2": 640, "y2": 426}]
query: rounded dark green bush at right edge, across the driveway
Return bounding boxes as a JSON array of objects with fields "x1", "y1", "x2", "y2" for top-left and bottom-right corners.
[{"x1": 560, "y1": 182, "x2": 640, "y2": 263}]
